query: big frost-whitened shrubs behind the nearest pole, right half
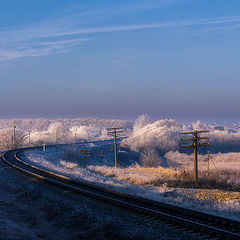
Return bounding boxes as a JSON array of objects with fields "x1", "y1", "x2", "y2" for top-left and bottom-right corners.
[{"x1": 123, "y1": 115, "x2": 240, "y2": 156}]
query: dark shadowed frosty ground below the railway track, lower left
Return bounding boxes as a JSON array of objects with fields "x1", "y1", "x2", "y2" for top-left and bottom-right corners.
[{"x1": 0, "y1": 154, "x2": 193, "y2": 240}]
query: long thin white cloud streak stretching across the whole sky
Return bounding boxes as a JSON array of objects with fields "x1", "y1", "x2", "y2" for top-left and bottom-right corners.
[{"x1": 0, "y1": 16, "x2": 240, "y2": 43}]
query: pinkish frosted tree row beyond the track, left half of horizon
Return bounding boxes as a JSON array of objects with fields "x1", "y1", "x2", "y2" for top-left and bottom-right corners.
[{"x1": 0, "y1": 118, "x2": 132, "y2": 150}]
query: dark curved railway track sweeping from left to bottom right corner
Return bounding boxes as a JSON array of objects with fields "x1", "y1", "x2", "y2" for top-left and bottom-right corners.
[{"x1": 2, "y1": 146, "x2": 240, "y2": 240}]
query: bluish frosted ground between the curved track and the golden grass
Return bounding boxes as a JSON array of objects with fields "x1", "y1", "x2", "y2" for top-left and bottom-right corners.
[{"x1": 21, "y1": 142, "x2": 240, "y2": 220}]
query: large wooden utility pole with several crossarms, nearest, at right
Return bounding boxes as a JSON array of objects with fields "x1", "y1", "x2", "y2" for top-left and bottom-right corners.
[{"x1": 181, "y1": 130, "x2": 210, "y2": 183}]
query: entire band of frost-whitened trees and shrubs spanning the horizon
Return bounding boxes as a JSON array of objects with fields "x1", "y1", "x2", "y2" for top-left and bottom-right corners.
[{"x1": 0, "y1": 115, "x2": 240, "y2": 157}]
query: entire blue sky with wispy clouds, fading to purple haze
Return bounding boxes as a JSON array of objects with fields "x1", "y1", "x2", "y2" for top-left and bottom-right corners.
[{"x1": 0, "y1": 0, "x2": 240, "y2": 121}]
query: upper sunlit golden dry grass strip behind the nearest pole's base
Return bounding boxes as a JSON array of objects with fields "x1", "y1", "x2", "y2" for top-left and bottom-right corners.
[{"x1": 90, "y1": 166, "x2": 240, "y2": 191}]
